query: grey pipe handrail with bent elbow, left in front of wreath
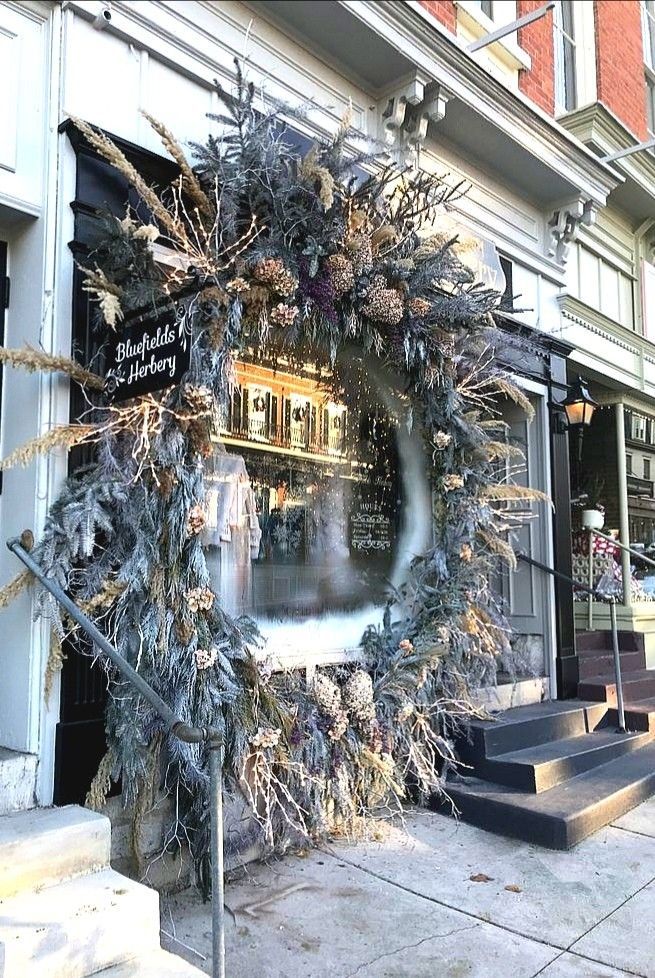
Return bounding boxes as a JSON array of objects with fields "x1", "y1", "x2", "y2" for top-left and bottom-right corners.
[{"x1": 7, "y1": 531, "x2": 225, "y2": 978}]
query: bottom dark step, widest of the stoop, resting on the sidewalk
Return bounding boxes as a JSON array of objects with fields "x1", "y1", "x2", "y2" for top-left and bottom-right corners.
[{"x1": 440, "y1": 742, "x2": 655, "y2": 849}]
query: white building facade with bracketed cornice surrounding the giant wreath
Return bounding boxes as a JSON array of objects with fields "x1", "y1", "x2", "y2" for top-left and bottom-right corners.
[{"x1": 0, "y1": 0, "x2": 624, "y2": 804}]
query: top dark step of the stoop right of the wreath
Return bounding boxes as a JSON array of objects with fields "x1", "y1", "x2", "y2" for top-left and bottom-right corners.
[{"x1": 458, "y1": 700, "x2": 607, "y2": 763}]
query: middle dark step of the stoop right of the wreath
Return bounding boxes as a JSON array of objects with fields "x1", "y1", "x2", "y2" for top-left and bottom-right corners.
[{"x1": 472, "y1": 727, "x2": 652, "y2": 793}]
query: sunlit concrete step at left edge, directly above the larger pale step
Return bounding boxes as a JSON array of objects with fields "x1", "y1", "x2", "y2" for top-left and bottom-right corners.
[{"x1": 0, "y1": 805, "x2": 110, "y2": 899}]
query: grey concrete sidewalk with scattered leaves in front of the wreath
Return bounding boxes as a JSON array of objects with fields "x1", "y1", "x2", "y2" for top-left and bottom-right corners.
[{"x1": 162, "y1": 799, "x2": 655, "y2": 978}]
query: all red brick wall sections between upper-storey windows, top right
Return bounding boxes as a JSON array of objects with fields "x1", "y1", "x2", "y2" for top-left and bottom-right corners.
[{"x1": 420, "y1": 0, "x2": 648, "y2": 139}]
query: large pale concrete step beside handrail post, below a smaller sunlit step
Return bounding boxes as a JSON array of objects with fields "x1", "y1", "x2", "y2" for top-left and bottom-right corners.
[{"x1": 0, "y1": 869, "x2": 160, "y2": 978}]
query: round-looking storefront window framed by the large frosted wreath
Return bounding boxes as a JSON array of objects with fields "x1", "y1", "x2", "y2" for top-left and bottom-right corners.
[{"x1": 205, "y1": 354, "x2": 431, "y2": 649}]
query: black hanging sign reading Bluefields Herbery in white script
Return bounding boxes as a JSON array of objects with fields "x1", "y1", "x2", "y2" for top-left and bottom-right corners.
[{"x1": 105, "y1": 305, "x2": 191, "y2": 401}]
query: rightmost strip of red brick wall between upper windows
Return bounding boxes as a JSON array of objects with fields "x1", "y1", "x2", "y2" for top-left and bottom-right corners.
[{"x1": 594, "y1": 0, "x2": 648, "y2": 139}]
